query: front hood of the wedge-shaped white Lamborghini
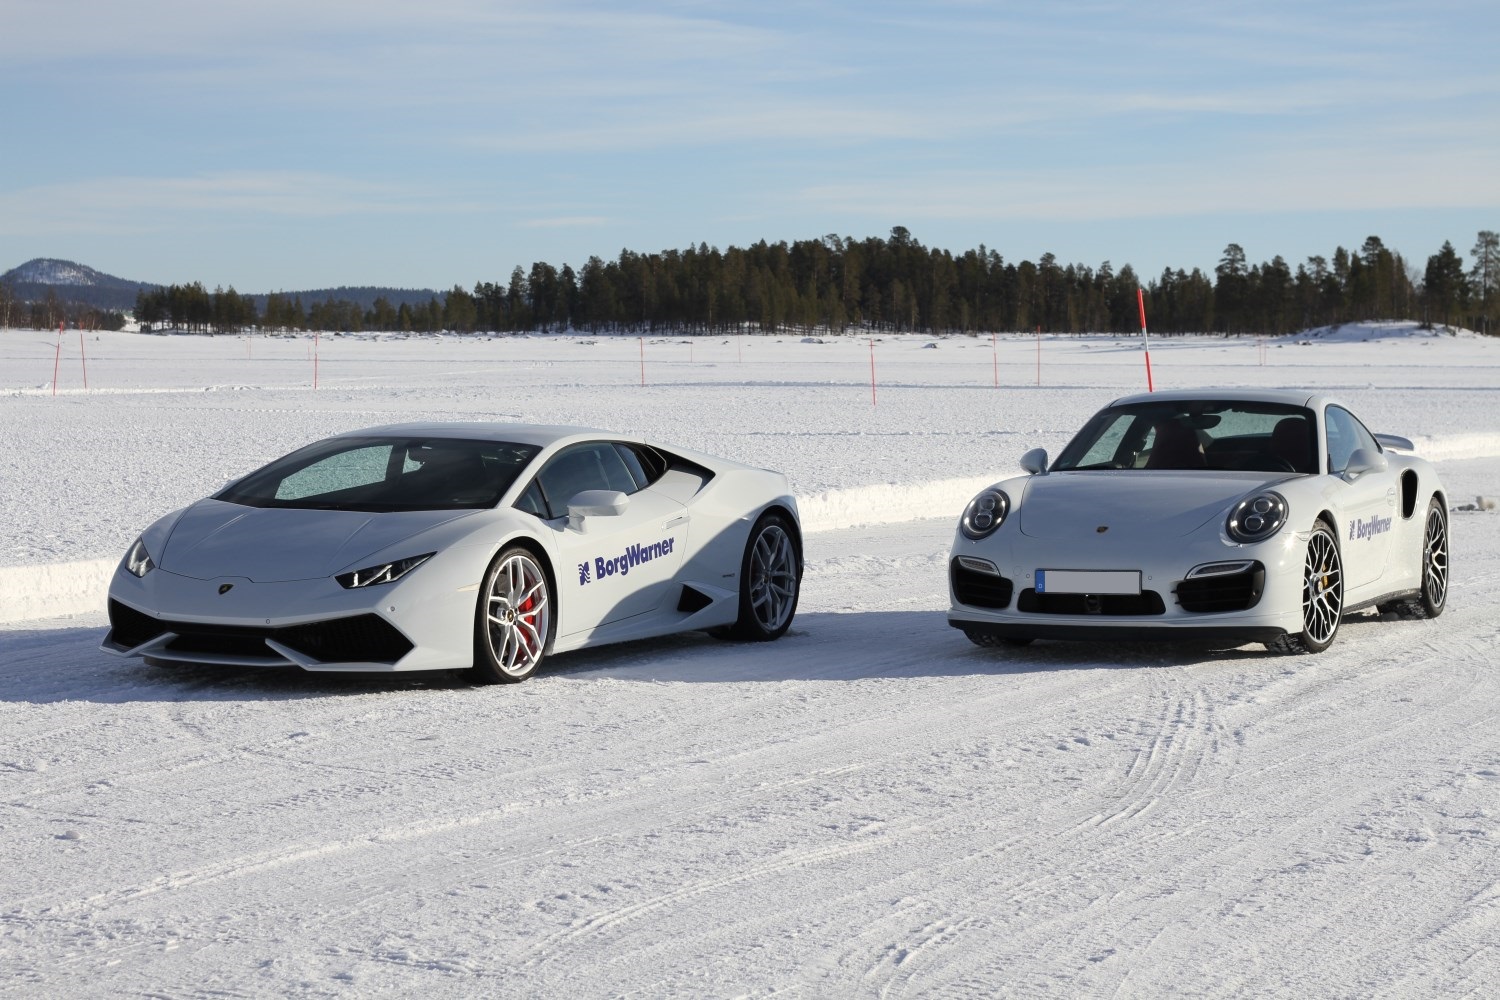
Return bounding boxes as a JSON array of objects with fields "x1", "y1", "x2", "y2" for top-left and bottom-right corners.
[{"x1": 152, "y1": 499, "x2": 477, "y2": 583}]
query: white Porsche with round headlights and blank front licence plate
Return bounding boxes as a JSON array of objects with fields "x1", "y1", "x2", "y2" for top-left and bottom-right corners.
[{"x1": 948, "y1": 390, "x2": 1449, "y2": 652}]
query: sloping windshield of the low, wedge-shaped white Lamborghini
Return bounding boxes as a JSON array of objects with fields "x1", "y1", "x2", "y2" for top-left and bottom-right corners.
[{"x1": 215, "y1": 438, "x2": 540, "y2": 513}]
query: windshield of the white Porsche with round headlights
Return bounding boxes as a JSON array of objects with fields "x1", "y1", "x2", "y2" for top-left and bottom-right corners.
[{"x1": 1052, "y1": 399, "x2": 1317, "y2": 474}]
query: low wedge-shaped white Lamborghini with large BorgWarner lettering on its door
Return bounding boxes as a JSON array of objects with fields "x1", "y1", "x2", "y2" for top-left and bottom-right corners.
[{"x1": 104, "y1": 423, "x2": 803, "y2": 682}]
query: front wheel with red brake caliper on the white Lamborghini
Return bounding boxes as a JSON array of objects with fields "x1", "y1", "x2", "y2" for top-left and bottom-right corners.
[{"x1": 470, "y1": 546, "x2": 552, "y2": 684}]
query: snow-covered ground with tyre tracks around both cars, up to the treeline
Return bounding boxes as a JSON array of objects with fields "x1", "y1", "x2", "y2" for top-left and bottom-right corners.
[{"x1": 0, "y1": 325, "x2": 1500, "y2": 999}]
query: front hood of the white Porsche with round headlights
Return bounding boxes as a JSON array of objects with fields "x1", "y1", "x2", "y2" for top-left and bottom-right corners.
[{"x1": 1019, "y1": 471, "x2": 1266, "y2": 538}]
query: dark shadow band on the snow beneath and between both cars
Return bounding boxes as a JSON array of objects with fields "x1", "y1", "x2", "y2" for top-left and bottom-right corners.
[{"x1": 0, "y1": 610, "x2": 1382, "y2": 705}]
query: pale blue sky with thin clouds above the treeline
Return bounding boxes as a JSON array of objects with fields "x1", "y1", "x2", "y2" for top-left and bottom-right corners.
[{"x1": 0, "y1": 0, "x2": 1500, "y2": 292}]
